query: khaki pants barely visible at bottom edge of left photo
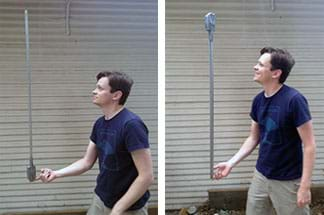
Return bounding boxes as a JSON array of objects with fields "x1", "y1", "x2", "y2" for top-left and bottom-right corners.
[{"x1": 87, "y1": 194, "x2": 148, "y2": 215}]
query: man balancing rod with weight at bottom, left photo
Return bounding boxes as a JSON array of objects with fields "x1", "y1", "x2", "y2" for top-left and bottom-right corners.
[{"x1": 39, "y1": 72, "x2": 153, "y2": 215}]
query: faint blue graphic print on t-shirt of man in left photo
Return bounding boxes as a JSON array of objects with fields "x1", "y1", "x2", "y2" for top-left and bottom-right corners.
[{"x1": 98, "y1": 130, "x2": 119, "y2": 171}]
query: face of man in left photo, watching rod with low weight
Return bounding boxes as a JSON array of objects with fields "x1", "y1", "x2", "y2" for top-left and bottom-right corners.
[{"x1": 92, "y1": 77, "x2": 114, "y2": 107}]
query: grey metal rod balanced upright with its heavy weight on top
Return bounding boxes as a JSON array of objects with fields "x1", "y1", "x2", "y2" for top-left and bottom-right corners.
[{"x1": 205, "y1": 12, "x2": 216, "y2": 178}]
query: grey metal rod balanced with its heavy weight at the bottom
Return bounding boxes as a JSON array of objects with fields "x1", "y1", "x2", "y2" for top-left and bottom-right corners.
[{"x1": 25, "y1": 10, "x2": 36, "y2": 181}]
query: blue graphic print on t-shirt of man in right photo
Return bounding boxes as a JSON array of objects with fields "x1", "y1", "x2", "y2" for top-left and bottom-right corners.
[{"x1": 260, "y1": 105, "x2": 281, "y2": 145}]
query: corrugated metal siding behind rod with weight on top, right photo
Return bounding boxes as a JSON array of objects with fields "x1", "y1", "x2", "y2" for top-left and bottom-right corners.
[{"x1": 165, "y1": 0, "x2": 324, "y2": 209}]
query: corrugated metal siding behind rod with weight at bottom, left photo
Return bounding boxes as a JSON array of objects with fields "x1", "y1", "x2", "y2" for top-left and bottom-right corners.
[{"x1": 0, "y1": 0, "x2": 157, "y2": 214}]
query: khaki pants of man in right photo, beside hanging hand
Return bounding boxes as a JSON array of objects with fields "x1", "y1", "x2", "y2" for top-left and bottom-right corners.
[{"x1": 246, "y1": 170, "x2": 310, "y2": 215}]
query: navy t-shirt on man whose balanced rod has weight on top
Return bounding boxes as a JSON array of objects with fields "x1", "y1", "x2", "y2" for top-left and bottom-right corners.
[{"x1": 250, "y1": 85, "x2": 311, "y2": 180}]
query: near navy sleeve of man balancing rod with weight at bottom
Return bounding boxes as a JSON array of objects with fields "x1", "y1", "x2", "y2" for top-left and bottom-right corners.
[{"x1": 125, "y1": 119, "x2": 149, "y2": 152}]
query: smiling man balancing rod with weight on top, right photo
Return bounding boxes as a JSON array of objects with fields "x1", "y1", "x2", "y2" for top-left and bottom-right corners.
[{"x1": 214, "y1": 47, "x2": 315, "y2": 215}]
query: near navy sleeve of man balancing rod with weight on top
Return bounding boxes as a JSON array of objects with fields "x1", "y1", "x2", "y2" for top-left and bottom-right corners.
[{"x1": 290, "y1": 94, "x2": 312, "y2": 128}]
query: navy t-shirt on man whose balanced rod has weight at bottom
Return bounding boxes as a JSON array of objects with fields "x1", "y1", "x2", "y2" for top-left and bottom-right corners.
[{"x1": 90, "y1": 108, "x2": 150, "y2": 210}]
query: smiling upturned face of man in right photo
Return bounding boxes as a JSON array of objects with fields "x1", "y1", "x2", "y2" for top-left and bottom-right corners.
[{"x1": 253, "y1": 53, "x2": 273, "y2": 84}]
